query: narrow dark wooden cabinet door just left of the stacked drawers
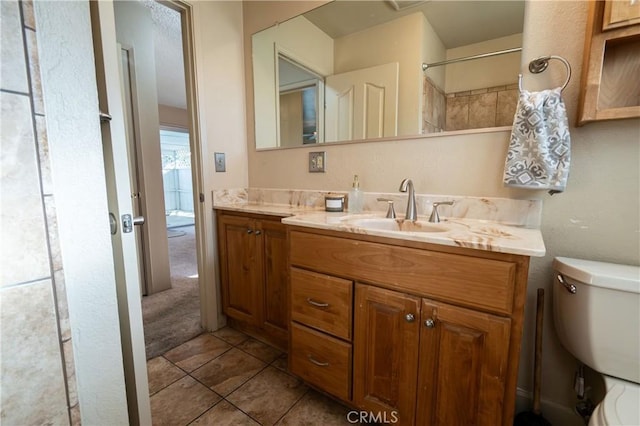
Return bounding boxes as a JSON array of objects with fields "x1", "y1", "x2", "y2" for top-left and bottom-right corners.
[{"x1": 260, "y1": 221, "x2": 289, "y2": 341}]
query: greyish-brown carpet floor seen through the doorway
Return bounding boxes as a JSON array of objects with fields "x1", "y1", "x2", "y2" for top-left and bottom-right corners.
[{"x1": 142, "y1": 226, "x2": 202, "y2": 359}]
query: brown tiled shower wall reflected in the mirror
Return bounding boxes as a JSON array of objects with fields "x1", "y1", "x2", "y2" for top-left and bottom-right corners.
[{"x1": 423, "y1": 77, "x2": 518, "y2": 133}]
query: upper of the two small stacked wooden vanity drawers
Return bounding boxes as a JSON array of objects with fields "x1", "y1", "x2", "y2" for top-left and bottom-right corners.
[{"x1": 291, "y1": 268, "x2": 353, "y2": 340}]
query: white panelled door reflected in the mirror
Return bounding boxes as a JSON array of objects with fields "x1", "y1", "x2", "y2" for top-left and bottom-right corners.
[{"x1": 325, "y1": 62, "x2": 399, "y2": 142}]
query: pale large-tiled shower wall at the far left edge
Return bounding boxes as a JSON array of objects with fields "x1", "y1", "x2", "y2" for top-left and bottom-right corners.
[{"x1": 0, "y1": 0, "x2": 80, "y2": 425}]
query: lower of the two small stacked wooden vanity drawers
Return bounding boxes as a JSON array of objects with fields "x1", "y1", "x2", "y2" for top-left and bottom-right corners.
[{"x1": 289, "y1": 323, "x2": 352, "y2": 401}]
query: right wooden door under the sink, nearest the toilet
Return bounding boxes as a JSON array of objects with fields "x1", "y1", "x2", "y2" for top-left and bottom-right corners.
[{"x1": 416, "y1": 300, "x2": 510, "y2": 426}]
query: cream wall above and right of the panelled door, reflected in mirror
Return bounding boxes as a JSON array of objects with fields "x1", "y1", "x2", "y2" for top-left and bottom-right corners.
[{"x1": 334, "y1": 13, "x2": 427, "y2": 136}]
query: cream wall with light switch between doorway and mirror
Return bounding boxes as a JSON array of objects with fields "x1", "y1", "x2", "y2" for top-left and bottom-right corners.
[{"x1": 190, "y1": 1, "x2": 246, "y2": 330}]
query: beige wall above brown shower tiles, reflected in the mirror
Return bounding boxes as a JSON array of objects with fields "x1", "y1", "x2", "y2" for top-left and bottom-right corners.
[{"x1": 440, "y1": 34, "x2": 522, "y2": 93}]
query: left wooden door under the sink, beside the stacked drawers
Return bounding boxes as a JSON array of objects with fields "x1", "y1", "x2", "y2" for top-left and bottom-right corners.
[{"x1": 353, "y1": 284, "x2": 420, "y2": 425}]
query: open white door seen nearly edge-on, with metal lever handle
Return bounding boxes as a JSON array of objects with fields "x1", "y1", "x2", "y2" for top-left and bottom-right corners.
[{"x1": 90, "y1": 1, "x2": 151, "y2": 424}]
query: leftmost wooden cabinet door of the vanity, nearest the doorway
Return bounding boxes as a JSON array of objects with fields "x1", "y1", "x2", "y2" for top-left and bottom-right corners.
[{"x1": 218, "y1": 216, "x2": 262, "y2": 325}]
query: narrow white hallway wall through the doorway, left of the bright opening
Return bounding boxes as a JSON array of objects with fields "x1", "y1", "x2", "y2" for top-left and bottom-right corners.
[{"x1": 114, "y1": 1, "x2": 171, "y2": 294}]
